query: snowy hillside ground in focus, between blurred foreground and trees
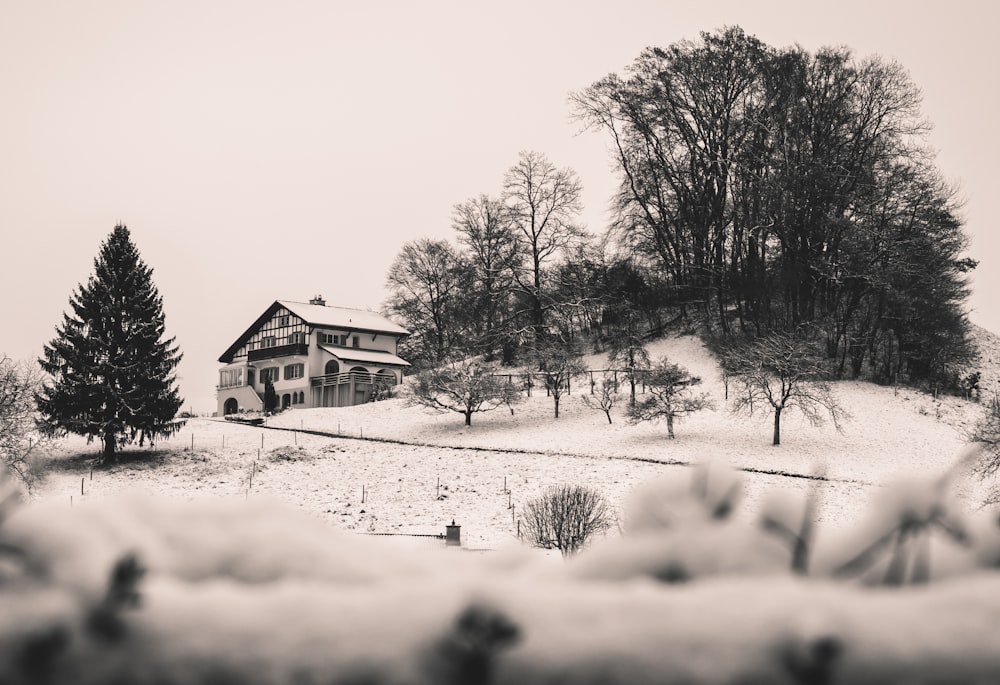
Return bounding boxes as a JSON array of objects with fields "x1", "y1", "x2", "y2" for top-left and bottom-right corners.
[{"x1": 31, "y1": 336, "x2": 992, "y2": 549}]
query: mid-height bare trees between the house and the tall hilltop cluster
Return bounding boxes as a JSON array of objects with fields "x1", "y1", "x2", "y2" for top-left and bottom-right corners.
[{"x1": 387, "y1": 151, "x2": 585, "y2": 365}]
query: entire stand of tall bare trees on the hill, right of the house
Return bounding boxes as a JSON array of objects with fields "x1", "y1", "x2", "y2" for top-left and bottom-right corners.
[{"x1": 387, "y1": 27, "x2": 975, "y2": 400}]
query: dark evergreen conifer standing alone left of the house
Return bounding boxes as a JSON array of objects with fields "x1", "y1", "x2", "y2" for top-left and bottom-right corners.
[{"x1": 37, "y1": 225, "x2": 183, "y2": 460}]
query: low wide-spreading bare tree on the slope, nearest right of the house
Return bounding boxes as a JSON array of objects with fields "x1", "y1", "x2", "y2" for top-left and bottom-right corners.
[{"x1": 409, "y1": 362, "x2": 521, "y2": 426}]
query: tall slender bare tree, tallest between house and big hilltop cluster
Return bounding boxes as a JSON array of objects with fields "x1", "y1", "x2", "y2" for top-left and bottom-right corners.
[{"x1": 504, "y1": 151, "x2": 583, "y2": 337}]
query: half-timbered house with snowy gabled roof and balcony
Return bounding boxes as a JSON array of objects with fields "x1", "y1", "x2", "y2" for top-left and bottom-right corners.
[{"x1": 216, "y1": 297, "x2": 409, "y2": 415}]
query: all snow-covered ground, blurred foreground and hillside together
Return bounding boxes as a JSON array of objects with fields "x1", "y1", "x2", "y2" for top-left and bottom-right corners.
[{"x1": 15, "y1": 338, "x2": 1000, "y2": 685}]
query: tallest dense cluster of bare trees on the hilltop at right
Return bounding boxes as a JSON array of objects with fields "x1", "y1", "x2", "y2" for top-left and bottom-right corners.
[{"x1": 572, "y1": 27, "x2": 975, "y2": 390}]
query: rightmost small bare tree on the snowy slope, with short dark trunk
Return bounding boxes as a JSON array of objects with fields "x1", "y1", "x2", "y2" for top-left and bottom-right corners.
[{"x1": 723, "y1": 333, "x2": 848, "y2": 445}]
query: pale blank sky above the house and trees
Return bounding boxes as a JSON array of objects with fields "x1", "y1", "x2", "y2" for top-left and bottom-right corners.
[{"x1": 0, "y1": 0, "x2": 1000, "y2": 412}]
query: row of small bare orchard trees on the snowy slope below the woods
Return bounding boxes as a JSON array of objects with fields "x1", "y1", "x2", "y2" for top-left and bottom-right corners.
[{"x1": 407, "y1": 326, "x2": 848, "y2": 448}]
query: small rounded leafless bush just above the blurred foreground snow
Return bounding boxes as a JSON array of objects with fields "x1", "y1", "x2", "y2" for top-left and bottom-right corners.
[{"x1": 521, "y1": 485, "x2": 614, "y2": 557}]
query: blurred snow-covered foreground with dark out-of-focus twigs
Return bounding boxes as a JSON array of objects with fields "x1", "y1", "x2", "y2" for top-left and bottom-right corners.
[{"x1": 0, "y1": 452, "x2": 1000, "y2": 685}]
